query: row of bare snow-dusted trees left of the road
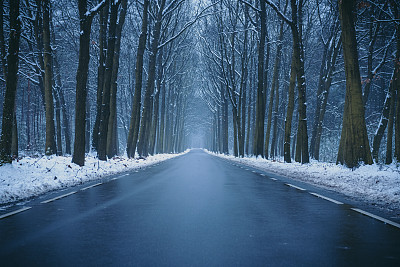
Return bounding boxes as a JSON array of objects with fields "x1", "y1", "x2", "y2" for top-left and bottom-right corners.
[{"x1": 0, "y1": 0, "x2": 200, "y2": 166}]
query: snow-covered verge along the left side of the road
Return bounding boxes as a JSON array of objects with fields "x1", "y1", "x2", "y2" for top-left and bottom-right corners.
[{"x1": 0, "y1": 151, "x2": 187, "y2": 204}]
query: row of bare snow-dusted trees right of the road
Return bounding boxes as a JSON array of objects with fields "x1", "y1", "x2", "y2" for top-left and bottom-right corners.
[{"x1": 200, "y1": 0, "x2": 400, "y2": 167}]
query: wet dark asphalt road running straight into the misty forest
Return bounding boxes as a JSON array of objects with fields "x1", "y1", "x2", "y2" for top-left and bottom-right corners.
[{"x1": 0, "y1": 150, "x2": 400, "y2": 266}]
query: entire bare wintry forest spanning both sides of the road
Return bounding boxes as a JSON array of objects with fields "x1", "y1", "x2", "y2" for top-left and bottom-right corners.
[{"x1": 0, "y1": 0, "x2": 400, "y2": 168}]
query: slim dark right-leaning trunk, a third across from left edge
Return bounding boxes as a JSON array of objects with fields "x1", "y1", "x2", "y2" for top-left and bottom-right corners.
[{"x1": 126, "y1": 0, "x2": 149, "y2": 158}]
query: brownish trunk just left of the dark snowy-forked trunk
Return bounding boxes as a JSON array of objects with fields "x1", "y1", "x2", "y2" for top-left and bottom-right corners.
[{"x1": 43, "y1": 0, "x2": 57, "y2": 155}]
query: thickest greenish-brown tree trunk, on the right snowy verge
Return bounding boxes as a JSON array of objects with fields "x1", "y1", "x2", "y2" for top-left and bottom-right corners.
[{"x1": 337, "y1": 0, "x2": 372, "y2": 168}]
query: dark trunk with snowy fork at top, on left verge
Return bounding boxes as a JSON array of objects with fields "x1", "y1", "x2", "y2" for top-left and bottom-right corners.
[{"x1": 72, "y1": 0, "x2": 106, "y2": 166}]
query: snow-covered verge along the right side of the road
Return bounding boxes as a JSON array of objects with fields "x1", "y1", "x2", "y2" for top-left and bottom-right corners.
[{"x1": 208, "y1": 152, "x2": 400, "y2": 213}]
